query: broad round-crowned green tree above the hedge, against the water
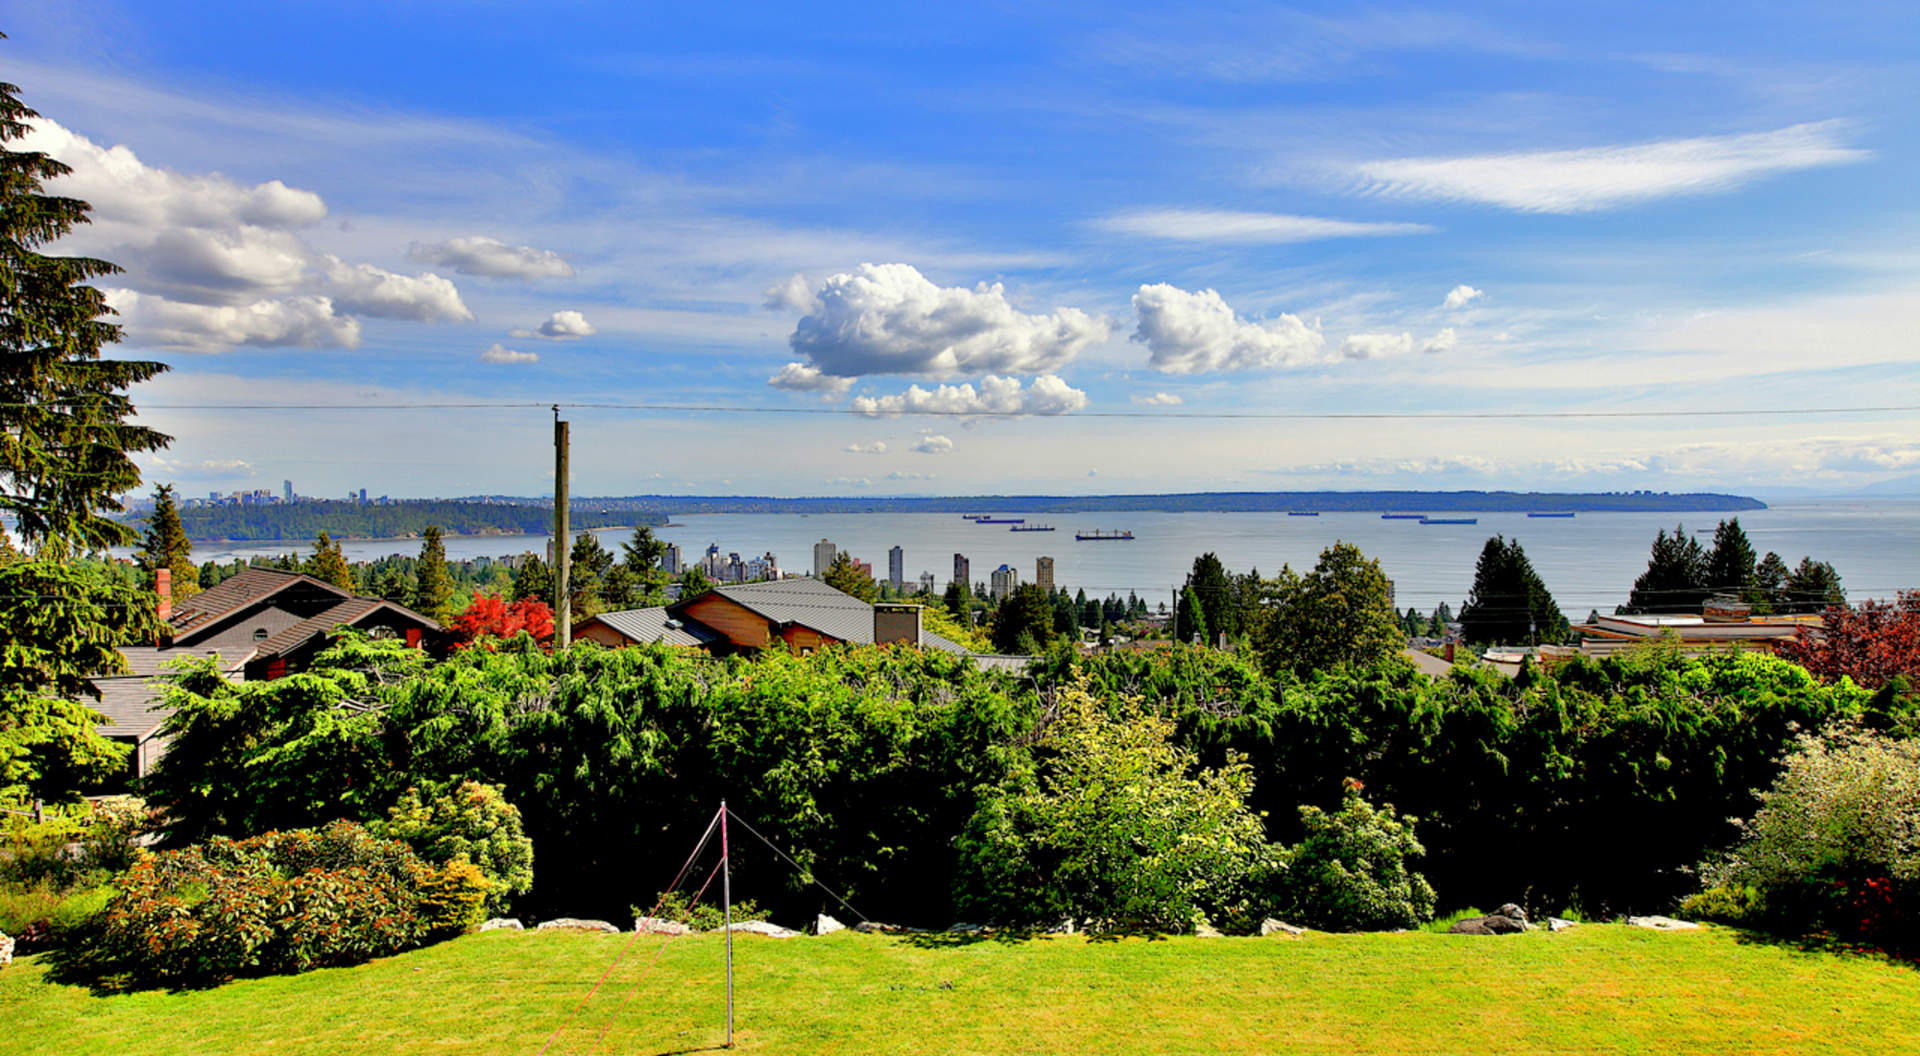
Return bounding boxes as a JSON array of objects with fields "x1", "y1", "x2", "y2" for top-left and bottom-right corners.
[{"x1": 1251, "y1": 543, "x2": 1407, "y2": 678}]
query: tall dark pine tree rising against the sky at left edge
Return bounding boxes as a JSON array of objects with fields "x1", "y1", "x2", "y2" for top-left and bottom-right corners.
[{"x1": 0, "y1": 68, "x2": 179, "y2": 552}]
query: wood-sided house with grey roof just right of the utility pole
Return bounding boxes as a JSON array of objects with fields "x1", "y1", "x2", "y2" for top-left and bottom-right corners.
[{"x1": 574, "y1": 580, "x2": 1029, "y2": 668}]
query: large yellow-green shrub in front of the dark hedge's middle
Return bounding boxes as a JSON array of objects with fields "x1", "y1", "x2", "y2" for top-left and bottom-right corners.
[{"x1": 956, "y1": 685, "x2": 1275, "y2": 931}]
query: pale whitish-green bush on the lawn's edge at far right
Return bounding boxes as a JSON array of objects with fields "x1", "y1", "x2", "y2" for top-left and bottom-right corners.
[{"x1": 1701, "y1": 728, "x2": 1920, "y2": 950}]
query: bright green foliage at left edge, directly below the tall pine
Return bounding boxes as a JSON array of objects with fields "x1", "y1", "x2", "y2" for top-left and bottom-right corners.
[{"x1": 0, "y1": 561, "x2": 161, "y2": 799}]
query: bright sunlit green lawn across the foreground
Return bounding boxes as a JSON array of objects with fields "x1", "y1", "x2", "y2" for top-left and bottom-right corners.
[{"x1": 0, "y1": 925, "x2": 1920, "y2": 1056}]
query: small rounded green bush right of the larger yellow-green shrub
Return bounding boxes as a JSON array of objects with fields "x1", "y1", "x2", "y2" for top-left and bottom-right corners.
[{"x1": 1281, "y1": 781, "x2": 1434, "y2": 931}]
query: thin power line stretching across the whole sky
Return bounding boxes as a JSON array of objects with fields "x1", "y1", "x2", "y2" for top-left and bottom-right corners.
[{"x1": 0, "y1": 401, "x2": 1920, "y2": 420}]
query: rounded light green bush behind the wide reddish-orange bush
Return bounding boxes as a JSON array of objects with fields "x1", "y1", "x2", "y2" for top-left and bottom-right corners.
[{"x1": 374, "y1": 781, "x2": 534, "y2": 914}]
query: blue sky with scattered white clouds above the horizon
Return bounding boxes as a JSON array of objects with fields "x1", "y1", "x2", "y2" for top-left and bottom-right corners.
[{"x1": 0, "y1": 0, "x2": 1920, "y2": 495}]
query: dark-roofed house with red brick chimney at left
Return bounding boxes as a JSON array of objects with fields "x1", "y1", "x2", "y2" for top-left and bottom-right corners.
[{"x1": 92, "y1": 568, "x2": 444, "y2": 778}]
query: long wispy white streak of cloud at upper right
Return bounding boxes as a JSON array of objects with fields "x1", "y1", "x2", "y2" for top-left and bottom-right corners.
[{"x1": 1352, "y1": 121, "x2": 1872, "y2": 213}]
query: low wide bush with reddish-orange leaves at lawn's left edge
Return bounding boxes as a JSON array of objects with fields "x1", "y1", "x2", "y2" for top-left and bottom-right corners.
[{"x1": 100, "y1": 822, "x2": 438, "y2": 983}]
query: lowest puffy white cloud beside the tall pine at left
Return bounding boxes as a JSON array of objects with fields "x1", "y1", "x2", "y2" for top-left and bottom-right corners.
[{"x1": 104, "y1": 290, "x2": 359, "y2": 351}]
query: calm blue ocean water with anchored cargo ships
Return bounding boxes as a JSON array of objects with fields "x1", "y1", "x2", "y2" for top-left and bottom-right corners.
[{"x1": 183, "y1": 501, "x2": 1920, "y2": 620}]
